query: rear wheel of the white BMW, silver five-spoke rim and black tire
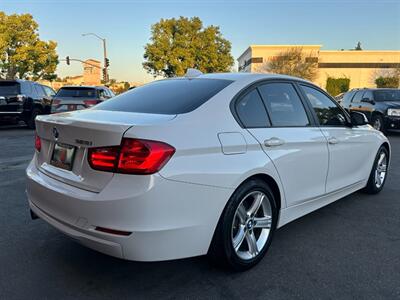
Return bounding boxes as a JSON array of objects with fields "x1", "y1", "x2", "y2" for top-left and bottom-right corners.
[{"x1": 208, "y1": 179, "x2": 278, "y2": 271}]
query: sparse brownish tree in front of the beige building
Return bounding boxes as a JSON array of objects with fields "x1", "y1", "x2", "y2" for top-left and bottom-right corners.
[{"x1": 259, "y1": 47, "x2": 318, "y2": 80}]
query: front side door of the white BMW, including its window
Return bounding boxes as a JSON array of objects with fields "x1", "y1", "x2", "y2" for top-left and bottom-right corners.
[{"x1": 300, "y1": 84, "x2": 371, "y2": 193}]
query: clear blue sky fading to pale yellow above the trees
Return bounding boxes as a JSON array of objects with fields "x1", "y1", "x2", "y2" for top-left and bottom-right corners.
[{"x1": 0, "y1": 0, "x2": 400, "y2": 82}]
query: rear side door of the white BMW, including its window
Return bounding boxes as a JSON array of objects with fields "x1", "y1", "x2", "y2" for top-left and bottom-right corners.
[{"x1": 242, "y1": 81, "x2": 328, "y2": 206}]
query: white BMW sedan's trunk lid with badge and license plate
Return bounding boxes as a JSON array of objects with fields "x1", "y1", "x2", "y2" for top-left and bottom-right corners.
[{"x1": 36, "y1": 109, "x2": 175, "y2": 192}]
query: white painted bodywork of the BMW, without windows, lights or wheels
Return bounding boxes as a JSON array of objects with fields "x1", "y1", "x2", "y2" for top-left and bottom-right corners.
[{"x1": 27, "y1": 74, "x2": 388, "y2": 261}]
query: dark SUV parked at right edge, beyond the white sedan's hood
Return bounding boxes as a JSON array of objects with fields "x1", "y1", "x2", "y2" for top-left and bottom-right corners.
[{"x1": 342, "y1": 89, "x2": 400, "y2": 133}]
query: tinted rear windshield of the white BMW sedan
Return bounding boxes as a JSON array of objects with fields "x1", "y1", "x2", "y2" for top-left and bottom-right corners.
[{"x1": 95, "y1": 78, "x2": 232, "y2": 115}]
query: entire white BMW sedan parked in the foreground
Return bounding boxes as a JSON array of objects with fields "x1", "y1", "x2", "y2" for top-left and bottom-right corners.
[{"x1": 26, "y1": 73, "x2": 390, "y2": 270}]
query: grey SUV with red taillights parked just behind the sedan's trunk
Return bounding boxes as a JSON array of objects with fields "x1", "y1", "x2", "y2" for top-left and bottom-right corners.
[{"x1": 51, "y1": 86, "x2": 115, "y2": 113}]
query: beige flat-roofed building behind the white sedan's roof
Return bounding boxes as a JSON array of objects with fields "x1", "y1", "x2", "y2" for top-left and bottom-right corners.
[{"x1": 238, "y1": 45, "x2": 400, "y2": 88}]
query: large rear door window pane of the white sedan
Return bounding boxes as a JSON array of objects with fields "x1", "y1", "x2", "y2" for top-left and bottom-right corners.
[{"x1": 259, "y1": 83, "x2": 310, "y2": 127}]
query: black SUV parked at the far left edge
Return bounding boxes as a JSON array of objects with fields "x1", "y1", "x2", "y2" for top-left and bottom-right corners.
[{"x1": 0, "y1": 79, "x2": 55, "y2": 129}]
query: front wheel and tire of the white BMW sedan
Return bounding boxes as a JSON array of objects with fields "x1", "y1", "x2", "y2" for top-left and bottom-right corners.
[{"x1": 363, "y1": 146, "x2": 389, "y2": 195}]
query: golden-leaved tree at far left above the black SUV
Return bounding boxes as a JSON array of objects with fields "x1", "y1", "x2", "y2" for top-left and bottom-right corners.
[{"x1": 0, "y1": 12, "x2": 58, "y2": 80}]
